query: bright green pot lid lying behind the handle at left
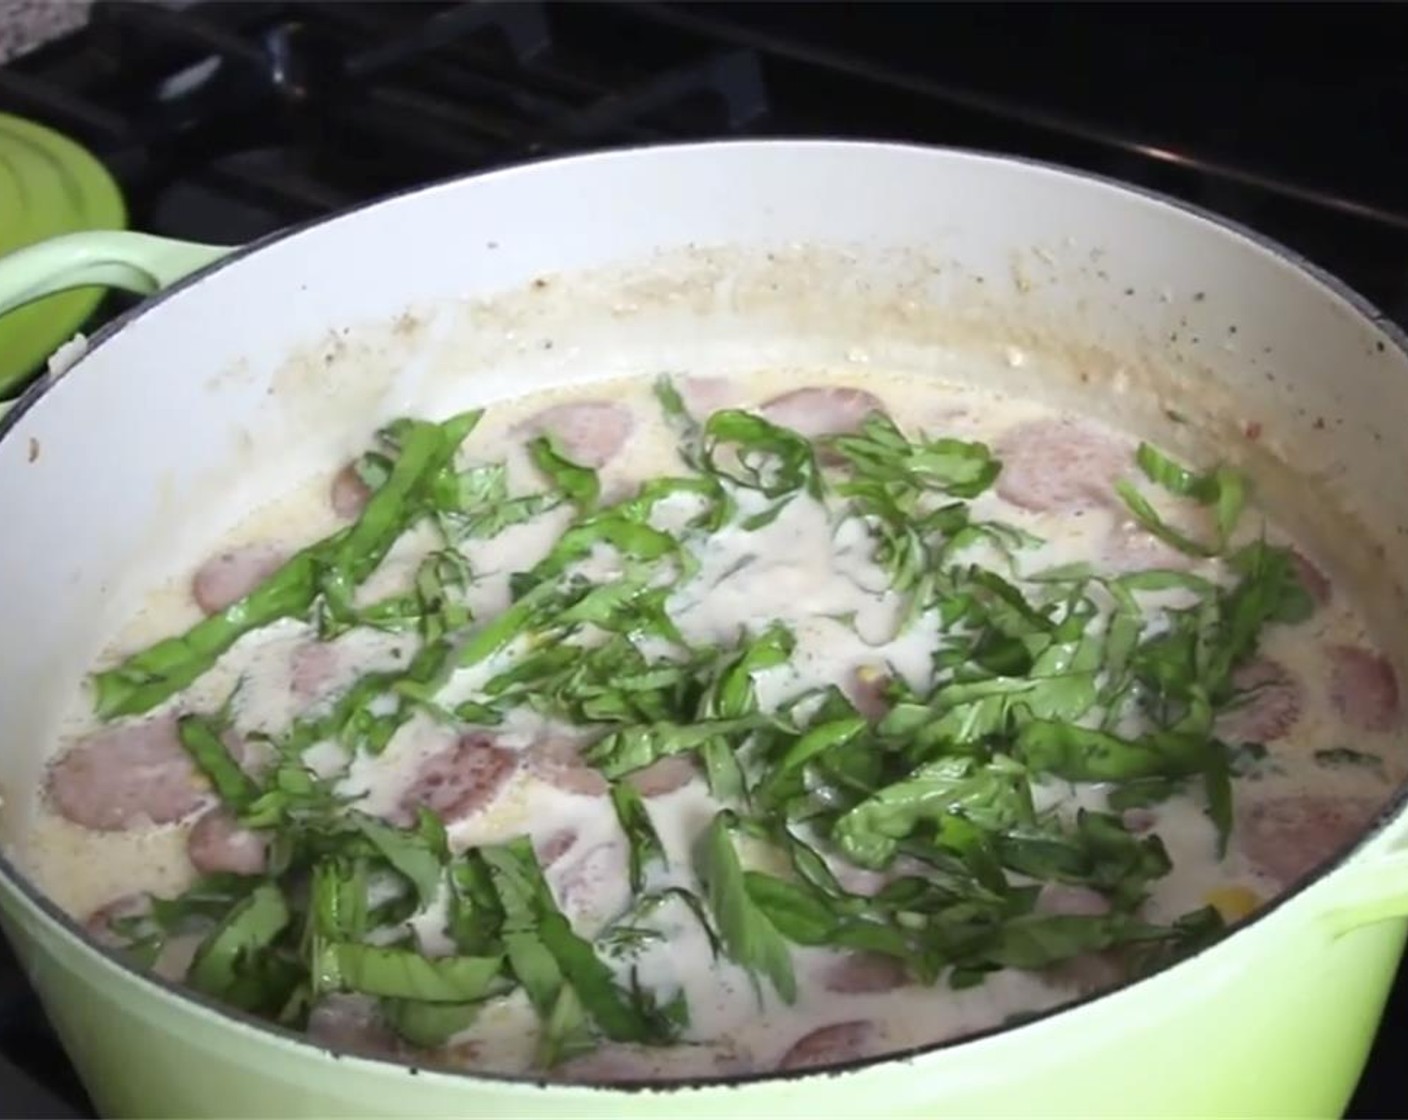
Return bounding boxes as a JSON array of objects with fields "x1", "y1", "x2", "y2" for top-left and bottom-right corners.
[{"x1": 0, "y1": 113, "x2": 127, "y2": 394}]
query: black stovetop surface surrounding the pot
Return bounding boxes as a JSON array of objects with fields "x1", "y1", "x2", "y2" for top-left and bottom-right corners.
[{"x1": 0, "y1": 0, "x2": 1408, "y2": 1117}]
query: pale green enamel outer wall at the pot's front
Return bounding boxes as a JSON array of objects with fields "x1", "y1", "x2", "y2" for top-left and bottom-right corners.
[{"x1": 0, "y1": 881, "x2": 1405, "y2": 1120}]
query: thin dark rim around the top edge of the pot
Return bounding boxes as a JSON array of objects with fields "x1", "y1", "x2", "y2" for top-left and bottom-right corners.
[{"x1": 0, "y1": 137, "x2": 1408, "y2": 1097}]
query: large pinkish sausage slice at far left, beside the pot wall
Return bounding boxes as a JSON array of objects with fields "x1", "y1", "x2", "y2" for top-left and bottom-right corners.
[{"x1": 48, "y1": 716, "x2": 210, "y2": 833}]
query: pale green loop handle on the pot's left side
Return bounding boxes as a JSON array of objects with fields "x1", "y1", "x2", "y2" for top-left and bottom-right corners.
[{"x1": 0, "y1": 231, "x2": 232, "y2": 316}]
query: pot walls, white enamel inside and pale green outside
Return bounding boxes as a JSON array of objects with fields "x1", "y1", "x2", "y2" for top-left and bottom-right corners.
[{"x1": 0, "y1": 142, "x2": 1408, "y2": 1117}]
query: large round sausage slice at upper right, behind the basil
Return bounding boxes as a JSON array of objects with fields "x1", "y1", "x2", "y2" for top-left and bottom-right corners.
[{"x1": 995, "y1": 418, "x2": 1133, "y2": 511}]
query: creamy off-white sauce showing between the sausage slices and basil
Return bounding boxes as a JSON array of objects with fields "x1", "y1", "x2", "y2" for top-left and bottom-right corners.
[{"x1": 13, "y1": 372, "x2": 1405, "y2": 1079}]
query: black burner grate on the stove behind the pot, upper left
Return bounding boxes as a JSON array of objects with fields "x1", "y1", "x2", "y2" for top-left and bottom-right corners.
[{"x1": 0, "y1": 0, "x2": 767, "y2": 239}]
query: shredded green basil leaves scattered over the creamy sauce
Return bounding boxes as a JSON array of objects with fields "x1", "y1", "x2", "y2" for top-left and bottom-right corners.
[{"x1": 94, "y1": 378, "x2": 1317, "y2": 1066}]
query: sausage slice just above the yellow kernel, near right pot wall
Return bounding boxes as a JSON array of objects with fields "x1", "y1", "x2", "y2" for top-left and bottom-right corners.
[{"x1": 1233, "y1": 793, "x2": 1380, "y2": 885}]
